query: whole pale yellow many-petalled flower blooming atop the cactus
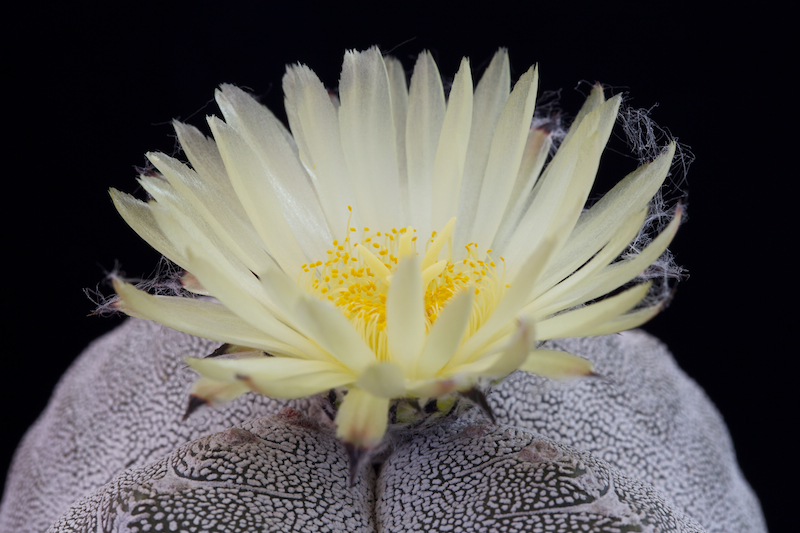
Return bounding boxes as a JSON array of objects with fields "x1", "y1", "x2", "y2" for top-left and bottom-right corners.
[{"x1": 111, "y1": 48, "x2": 680, "y2": 448}]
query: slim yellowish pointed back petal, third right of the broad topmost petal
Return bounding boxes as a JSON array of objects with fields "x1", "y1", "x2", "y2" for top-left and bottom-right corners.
[{"x1": 432, "y1": 58, "x2": 473, "y2": 231}]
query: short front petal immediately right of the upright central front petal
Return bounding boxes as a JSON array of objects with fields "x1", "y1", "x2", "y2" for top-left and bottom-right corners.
[{"x1": 416, "y1": 290, "x2": 475, "y2": 379}]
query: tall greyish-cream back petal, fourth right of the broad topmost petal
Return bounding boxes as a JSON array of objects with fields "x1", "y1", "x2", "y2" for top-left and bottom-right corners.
[{"x1": 454, "y1": 48, "x2": 511, "y2": 249}]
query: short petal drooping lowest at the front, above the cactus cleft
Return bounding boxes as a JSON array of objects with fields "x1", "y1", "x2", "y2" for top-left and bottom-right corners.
[{"x1": 335, "y1": 389, "x2": 389, "y2": 448}]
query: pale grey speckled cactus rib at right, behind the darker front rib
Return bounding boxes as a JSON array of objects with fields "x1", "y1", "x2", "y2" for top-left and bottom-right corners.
[{"x1": 478, "y1": 330, "x2": 766, "y2": 533}]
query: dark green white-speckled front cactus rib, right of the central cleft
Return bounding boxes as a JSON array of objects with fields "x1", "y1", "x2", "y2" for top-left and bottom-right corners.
[{"x1": 375, "y1": 420, "x2": 705, "y2": 533}]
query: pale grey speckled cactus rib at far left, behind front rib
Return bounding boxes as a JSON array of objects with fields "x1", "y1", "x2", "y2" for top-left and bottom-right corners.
[{"x1": 0, "y1": 319, "x2": 306, "y2": 533}]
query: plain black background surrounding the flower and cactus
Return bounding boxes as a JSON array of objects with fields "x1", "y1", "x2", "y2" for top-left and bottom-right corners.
[{"x1": 0, "y1": 2, "x2": 798, "y2": 531}]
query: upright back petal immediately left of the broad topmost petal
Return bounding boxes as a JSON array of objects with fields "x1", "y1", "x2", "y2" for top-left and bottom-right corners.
[{"x1": 283, "y1": 65, "x2": 357, "y2": 236}]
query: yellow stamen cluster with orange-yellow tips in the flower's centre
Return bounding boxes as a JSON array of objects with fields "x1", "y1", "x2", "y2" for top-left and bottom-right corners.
[{"x1": 298, "y1": 208, "x2": 508, "y2": 360}]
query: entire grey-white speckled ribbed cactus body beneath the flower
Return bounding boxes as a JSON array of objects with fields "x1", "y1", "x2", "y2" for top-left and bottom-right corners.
[{"x1": 0, "y1": 319, "x2": 766, "y2": 533}]
